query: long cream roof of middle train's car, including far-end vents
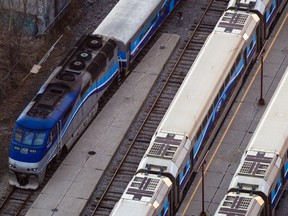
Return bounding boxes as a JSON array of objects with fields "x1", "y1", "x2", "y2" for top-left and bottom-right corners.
[{"x1": 157, "y1": 11, "x2": 259, "y2": 139}]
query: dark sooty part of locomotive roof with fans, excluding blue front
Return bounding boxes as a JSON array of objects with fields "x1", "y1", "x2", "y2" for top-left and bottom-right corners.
[{"x1": 27, "y1": 35, "x2": 116, "y2": 118}]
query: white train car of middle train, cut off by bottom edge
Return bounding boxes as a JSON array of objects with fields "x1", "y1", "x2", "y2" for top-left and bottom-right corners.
[{"x1": 110, "y1": 173, "x2": 172, "y2": 216}]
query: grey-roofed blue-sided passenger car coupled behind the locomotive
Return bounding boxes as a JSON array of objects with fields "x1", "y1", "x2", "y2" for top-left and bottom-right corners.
[{"x1": 93, "y1": 0, "x2": 180, "y2": 70}]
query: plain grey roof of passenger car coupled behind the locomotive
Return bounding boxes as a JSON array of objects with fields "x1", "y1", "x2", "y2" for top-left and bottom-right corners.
[{"x1": 93, "y1": 0, "x2": 165, "y2": 44}]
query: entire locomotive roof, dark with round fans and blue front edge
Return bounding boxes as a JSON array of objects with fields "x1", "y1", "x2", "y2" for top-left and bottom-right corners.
[{"x1": 17, "y1": 35, "x2": 116, "y2": 130}]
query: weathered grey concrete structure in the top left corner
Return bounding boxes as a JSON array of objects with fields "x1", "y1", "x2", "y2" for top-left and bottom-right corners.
[{"x1": 1, "y1": 0, "x2": 73, "y2": 35}]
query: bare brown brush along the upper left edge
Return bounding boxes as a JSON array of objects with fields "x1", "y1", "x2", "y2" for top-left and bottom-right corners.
[{"x1": 0, "y1": 0, "x2": 39, "y2": 97}]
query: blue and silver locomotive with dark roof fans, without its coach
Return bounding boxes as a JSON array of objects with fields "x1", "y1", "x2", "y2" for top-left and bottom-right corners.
[{"x1": 9, "y1": 35, "x2": 119, "y2": 189}]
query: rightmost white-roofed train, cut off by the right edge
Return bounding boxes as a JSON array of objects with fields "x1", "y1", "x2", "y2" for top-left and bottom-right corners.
[{"x1": 215, "y1": 68, "x2": 288, "y2": 216}]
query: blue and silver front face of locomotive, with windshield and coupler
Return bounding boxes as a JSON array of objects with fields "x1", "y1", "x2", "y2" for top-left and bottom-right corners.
[{"x1": 9, "y1": 125, "x2": 53, "y2": 189}]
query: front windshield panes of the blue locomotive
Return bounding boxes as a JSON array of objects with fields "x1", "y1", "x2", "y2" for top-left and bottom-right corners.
[{"x1": 14, "y1": 127, "x2": 46, "y2": 146}]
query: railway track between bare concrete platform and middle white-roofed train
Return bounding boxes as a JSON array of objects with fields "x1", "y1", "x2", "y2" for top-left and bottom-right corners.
[{"x1": 81, "y1": 0, "x2": 228, "y2": 216}]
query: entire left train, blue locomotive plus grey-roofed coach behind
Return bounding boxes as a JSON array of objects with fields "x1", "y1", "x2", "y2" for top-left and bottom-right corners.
[{"x1": 9, "y1": 0, "x2": 179, "y2": 189}]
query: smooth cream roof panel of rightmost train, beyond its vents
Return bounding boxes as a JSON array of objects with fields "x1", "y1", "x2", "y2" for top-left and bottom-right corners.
[{"x1": 247, "y1": 68, "x2": 288, "y2": 158}]
